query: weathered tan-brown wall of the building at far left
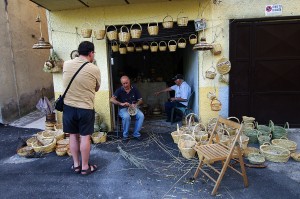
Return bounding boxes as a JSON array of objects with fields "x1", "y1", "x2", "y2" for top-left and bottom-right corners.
[{"x1": 0, "y1": 0, "x2": 54, "y2": 123}]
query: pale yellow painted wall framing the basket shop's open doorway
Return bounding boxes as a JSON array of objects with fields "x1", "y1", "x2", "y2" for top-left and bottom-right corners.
[{"x1": 49, "y1": 0, "x2": 300, "y2": 127}]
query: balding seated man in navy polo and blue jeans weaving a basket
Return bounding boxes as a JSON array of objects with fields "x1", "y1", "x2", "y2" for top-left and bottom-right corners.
[{"x1": 110, "y1": 76, "x2": 144, "y2": 141}]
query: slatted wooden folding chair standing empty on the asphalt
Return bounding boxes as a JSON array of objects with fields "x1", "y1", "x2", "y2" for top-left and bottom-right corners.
[{"x1": 194, "y1": 116, "x2": 248, "y2": 195}]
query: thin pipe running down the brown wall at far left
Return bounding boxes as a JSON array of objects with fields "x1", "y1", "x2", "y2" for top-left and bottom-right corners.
[{"x1": 4, "y1": 0, "x2": 21, "y2": 117}]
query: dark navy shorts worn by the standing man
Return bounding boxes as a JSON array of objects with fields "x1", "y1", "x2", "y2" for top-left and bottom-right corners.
[{"x1": 63, "y1": 104, "x2": 95, "y2": 136}]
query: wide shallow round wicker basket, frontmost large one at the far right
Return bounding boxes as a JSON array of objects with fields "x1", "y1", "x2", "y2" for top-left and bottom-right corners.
[{"x1": 260, "y1": 144, "x2": 291, "y2": 162}]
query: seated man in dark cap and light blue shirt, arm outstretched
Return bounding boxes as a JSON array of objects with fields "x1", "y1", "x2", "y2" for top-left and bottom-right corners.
[{"x1": 155, "y1": 74, "x2": 191, "y2": 122}]
